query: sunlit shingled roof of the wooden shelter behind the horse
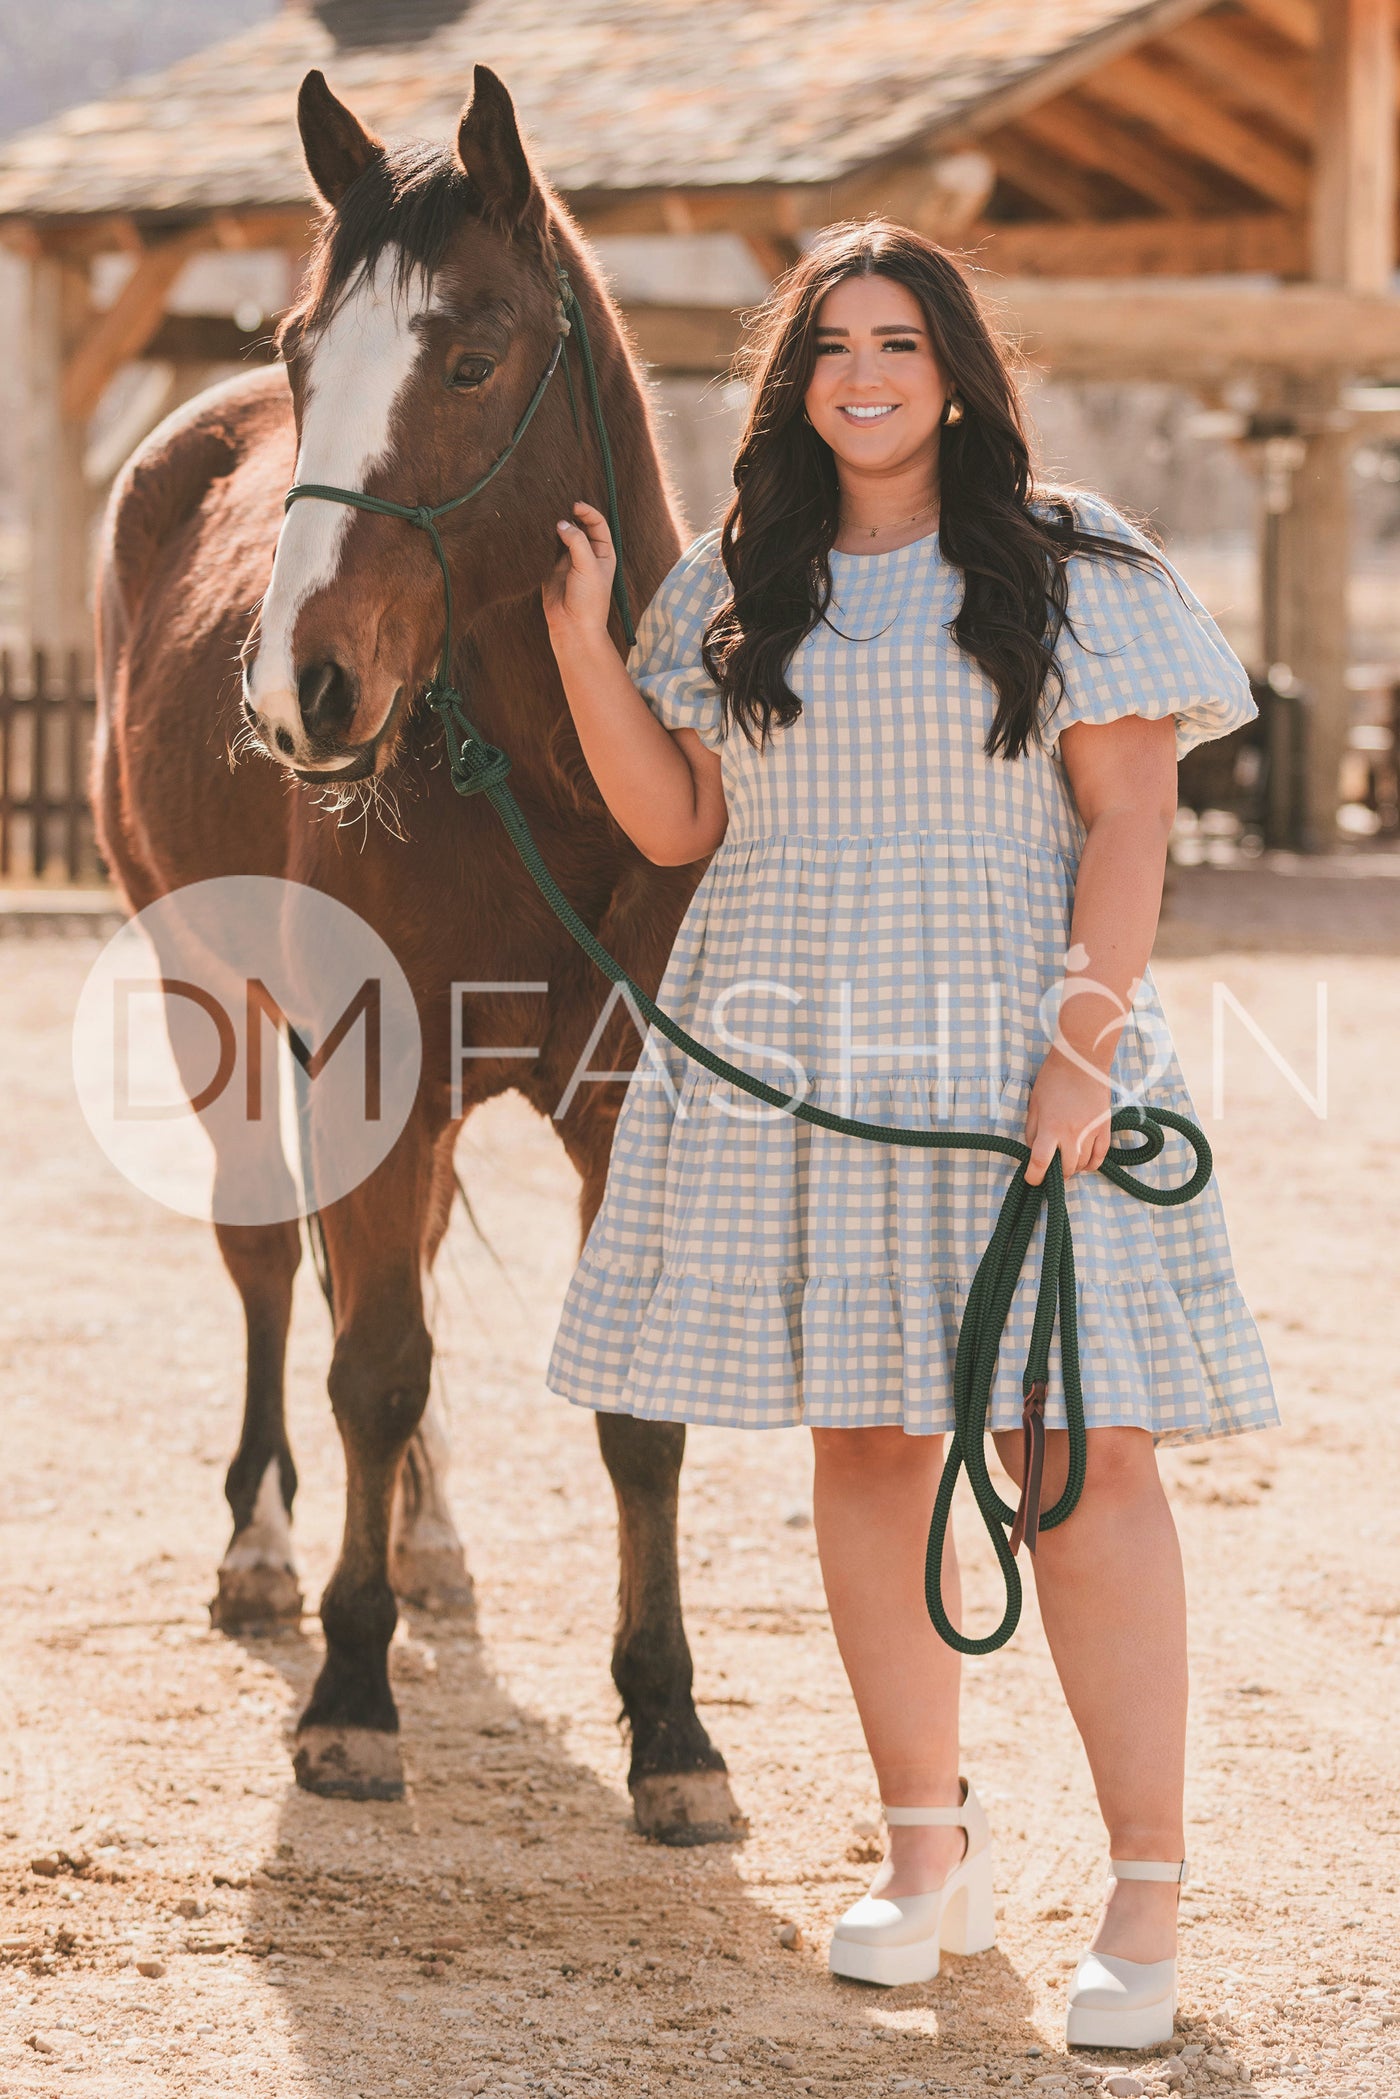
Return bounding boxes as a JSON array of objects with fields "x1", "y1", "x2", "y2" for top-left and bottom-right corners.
[{"x1": 0, "y1": 0, "x2": 1194, "y2": 220}]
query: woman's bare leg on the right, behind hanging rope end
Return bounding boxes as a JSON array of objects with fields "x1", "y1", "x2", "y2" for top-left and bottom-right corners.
[{"x1": 997, "y1": 1427, "x2": 1186, "y2": 1960}]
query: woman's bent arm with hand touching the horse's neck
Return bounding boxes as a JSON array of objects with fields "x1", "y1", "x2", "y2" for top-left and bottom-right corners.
[{"x1": 544, "y1": 504, "x2": 728, "y2": 867}]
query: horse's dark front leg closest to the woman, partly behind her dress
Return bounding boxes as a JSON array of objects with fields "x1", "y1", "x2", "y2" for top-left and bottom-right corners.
[{"x1": 560, "y1": 1108, "x2": 747, "y2": 1845}]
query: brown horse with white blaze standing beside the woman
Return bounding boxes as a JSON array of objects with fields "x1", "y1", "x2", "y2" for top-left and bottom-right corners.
[{"x1": 94, "y1": 67, "x2": 739, "y2": 1841}]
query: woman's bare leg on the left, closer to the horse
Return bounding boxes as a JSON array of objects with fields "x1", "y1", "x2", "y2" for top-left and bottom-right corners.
[{"x1": 812, "y1": 1429, "x2": 966, "y2": 1895}]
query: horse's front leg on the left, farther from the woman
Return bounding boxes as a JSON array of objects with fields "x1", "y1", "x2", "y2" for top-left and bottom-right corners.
[{"x1": 294, "y1": 1115, "x2": 434, "y2": 1801}]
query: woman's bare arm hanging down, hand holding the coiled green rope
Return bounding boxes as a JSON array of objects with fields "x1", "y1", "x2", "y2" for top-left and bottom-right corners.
[{"x1": 1024, "y1": 714, "x2": 1175, "y2": 1184}]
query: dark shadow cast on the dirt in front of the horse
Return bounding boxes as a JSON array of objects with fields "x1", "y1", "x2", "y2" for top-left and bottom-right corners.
[{"x1": 229, "y1": 1614, "x2": 1049, "y2": 2099}]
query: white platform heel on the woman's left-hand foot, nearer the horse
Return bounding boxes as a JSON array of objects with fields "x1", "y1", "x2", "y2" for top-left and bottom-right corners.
[{"x1": 829, "y1": 1778, "x2": 997, "y2": 1988}]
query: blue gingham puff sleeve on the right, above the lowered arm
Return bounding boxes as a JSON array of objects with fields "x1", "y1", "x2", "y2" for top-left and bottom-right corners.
[{"x1": 1041, "y1": 495, "x2": 1259, "y2": 760}]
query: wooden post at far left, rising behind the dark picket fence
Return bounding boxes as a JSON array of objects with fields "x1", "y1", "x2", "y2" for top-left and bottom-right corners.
[{"x1": 25, "y1": 254, "x2": 92, "y2": 651}]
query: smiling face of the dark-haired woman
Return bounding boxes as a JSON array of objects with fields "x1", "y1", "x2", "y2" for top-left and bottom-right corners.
[{"x1": 804, "y1": 277, "x2": 949, "y2": 472}]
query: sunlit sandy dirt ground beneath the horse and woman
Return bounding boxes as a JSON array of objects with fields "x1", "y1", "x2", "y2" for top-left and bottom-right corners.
[{"x1": 0, "y1": 865, "x2": 1400, "y2": 2099}]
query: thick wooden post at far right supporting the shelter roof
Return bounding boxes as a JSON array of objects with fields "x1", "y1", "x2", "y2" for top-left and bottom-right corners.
[{"x1": 1278, "y1": 0, "x2": 1396, "y2": 852}]
